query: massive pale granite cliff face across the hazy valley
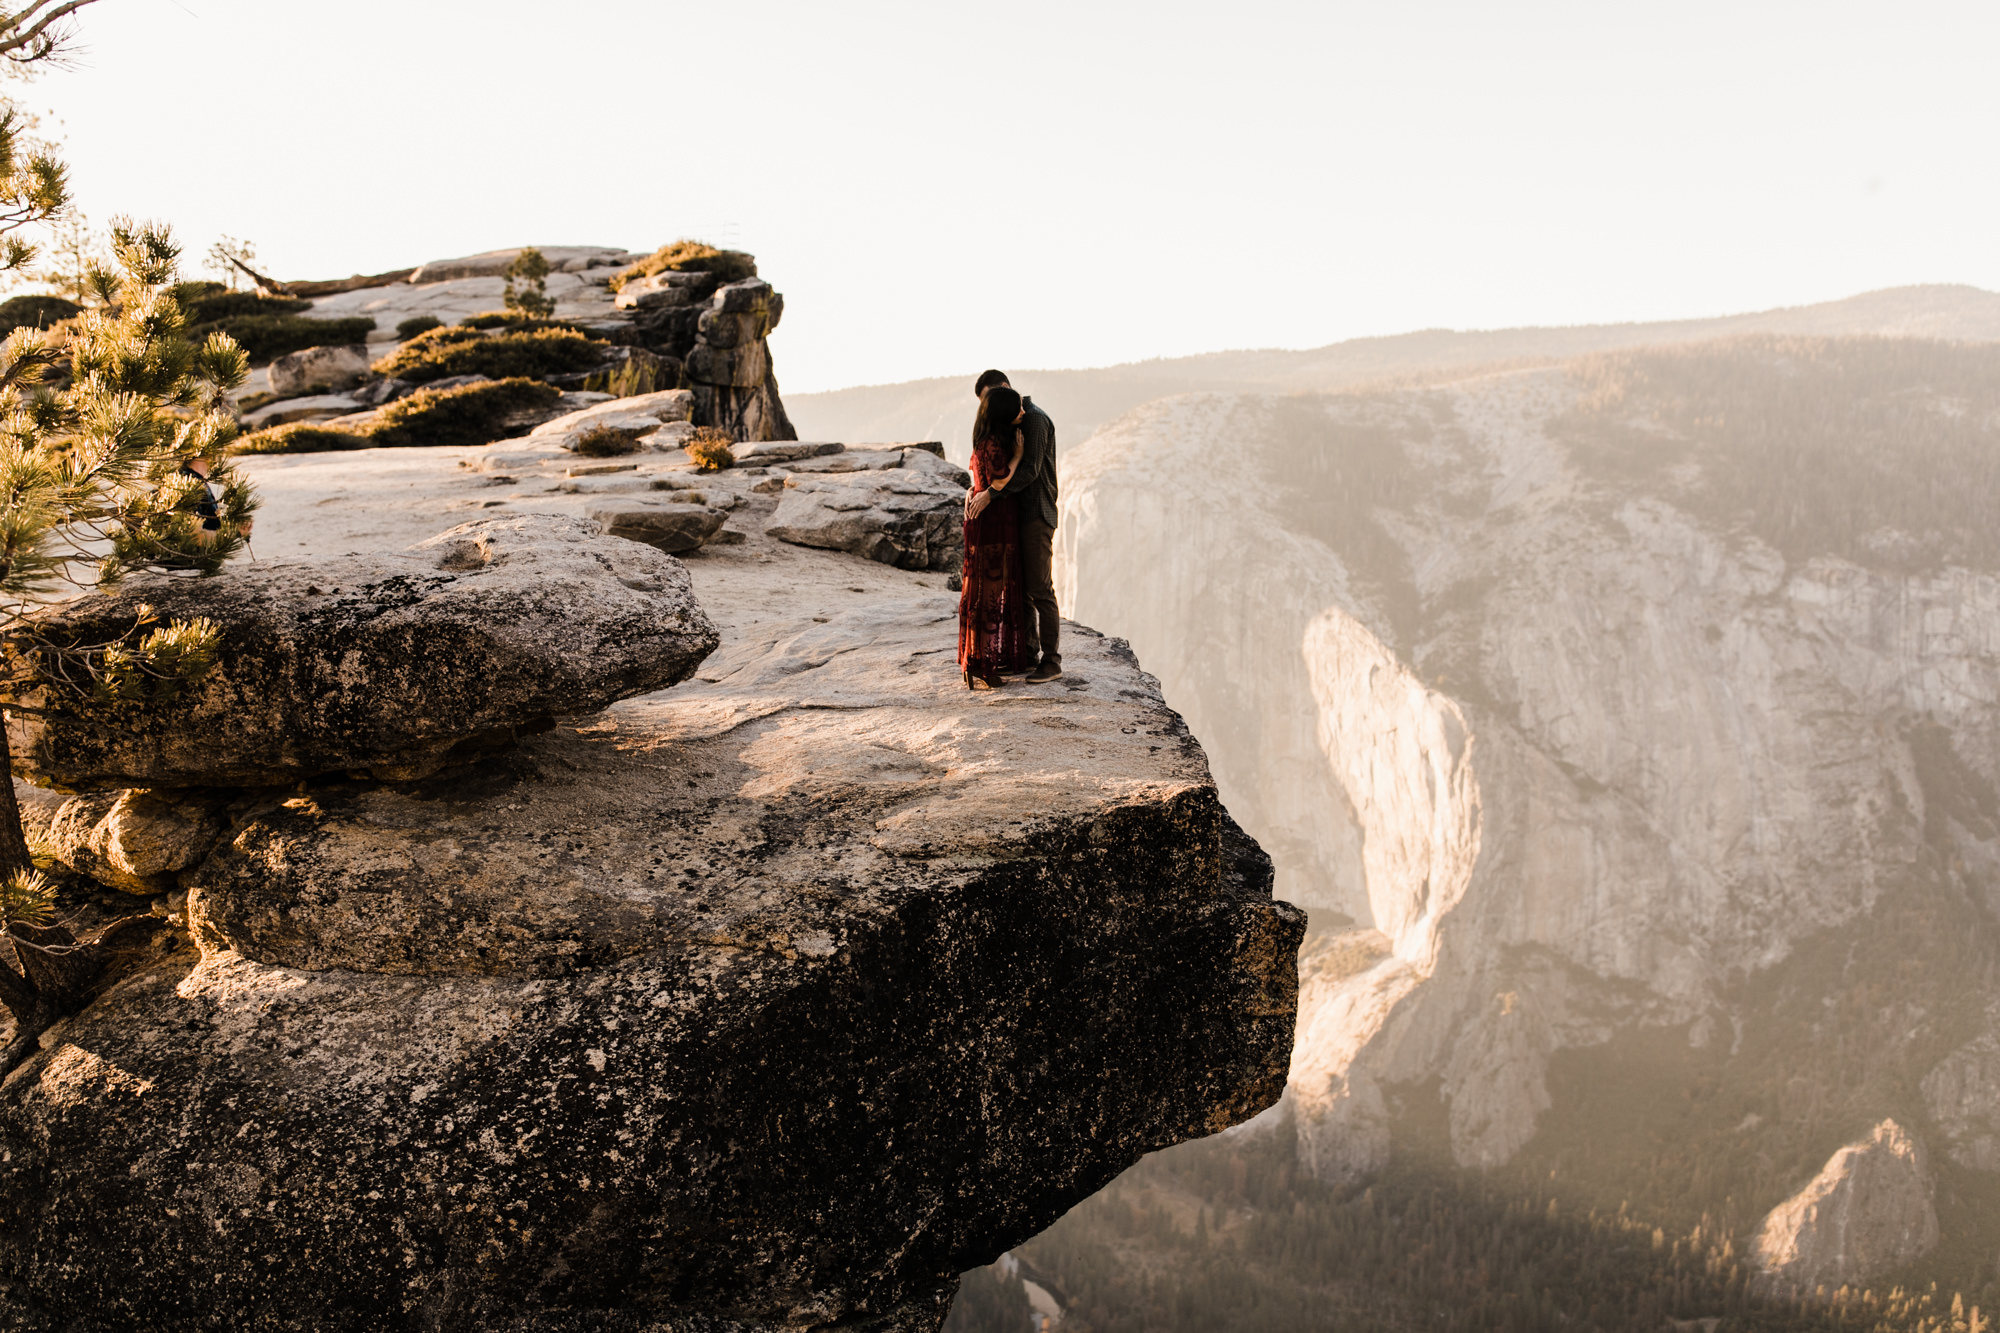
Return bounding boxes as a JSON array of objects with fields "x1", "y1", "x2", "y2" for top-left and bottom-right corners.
[{"x1": 1062, "y1": 336, "x2": 2000, "y2": 1285}]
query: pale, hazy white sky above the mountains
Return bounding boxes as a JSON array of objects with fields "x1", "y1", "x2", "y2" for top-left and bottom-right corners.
[{"x1": 22, "y1": 0, "x2": 2000, "y2": 392}]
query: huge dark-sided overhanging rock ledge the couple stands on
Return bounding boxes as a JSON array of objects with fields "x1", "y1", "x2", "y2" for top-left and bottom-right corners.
[{"x1": 0, "y1": 588, "x2": 1302, "y2": 1333}]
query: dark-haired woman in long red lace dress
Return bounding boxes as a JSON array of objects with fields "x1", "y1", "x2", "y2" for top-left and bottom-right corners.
[{"x1": 958, "y1": 384, "x2": 1034, "y2": 689}]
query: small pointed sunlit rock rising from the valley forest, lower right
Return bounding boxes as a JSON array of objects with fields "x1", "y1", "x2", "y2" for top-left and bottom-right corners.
[{"x1": 1750, "y1": 1121, "x2": 1938, "y2": 1297}]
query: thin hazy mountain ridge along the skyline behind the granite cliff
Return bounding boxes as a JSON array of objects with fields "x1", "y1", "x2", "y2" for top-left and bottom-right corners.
[{"x1": 784, "y1": 284, "x2": 2000, "y2": 458}]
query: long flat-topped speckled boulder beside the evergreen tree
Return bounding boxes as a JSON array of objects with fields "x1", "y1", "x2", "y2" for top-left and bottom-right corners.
[{"x1": 8, "y1": 514, "x2": 716, "y2": 789}]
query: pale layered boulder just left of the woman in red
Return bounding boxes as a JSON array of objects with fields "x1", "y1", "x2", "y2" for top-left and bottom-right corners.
[{"x1": 764, "y1": 448, "x2": 966, "y2": 570}]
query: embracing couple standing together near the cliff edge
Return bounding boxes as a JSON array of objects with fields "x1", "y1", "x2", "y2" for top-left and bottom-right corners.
[{"x1": 958, "y1": 370, "x2": 1062, "y2": 689}]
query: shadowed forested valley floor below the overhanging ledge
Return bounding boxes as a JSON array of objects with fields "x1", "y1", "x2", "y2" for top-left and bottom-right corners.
[{"x1": 948, "y1": 1127, "x2": 2000, "y2": 1333}]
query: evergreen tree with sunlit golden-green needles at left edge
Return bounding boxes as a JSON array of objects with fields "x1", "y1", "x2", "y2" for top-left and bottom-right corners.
[{"x1": 0, "y1": 0, "x2": 256, "y2": 1069}]
